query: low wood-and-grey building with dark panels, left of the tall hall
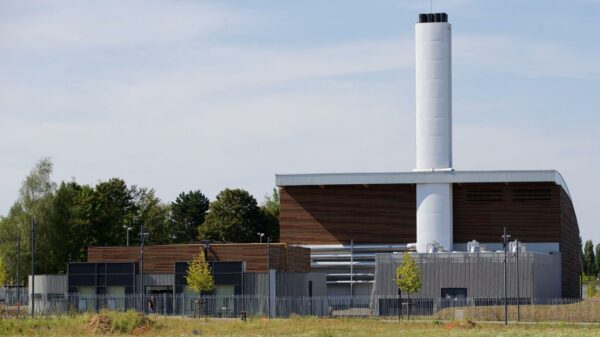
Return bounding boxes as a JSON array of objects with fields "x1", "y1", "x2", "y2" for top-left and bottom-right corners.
[{"x1": 29, "y1": 243, "x2": 326, "y2": 314}]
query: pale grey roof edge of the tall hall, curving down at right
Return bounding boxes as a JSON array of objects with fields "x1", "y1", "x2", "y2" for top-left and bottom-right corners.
[{"x1": 275, "y1": 170, "x2": 571, "y2": 198}]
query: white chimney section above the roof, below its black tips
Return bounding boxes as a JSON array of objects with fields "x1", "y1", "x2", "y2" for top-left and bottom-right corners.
[{"x1": 415, "y1": 17, "x2": 452, "y2": 170}]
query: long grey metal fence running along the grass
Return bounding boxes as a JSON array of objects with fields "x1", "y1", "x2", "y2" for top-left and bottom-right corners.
[{"x1": 5, "y1": 294, "x2": 600, "y2": 322}]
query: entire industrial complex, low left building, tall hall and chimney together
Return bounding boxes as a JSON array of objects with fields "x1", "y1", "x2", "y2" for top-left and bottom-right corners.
[{"x1": 28, "y1": 13, "x2": 581, "y2": 315}]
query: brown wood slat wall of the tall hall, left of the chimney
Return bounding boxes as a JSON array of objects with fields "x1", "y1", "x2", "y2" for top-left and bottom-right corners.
[{"x1": 279, "y1": 185, "x2": 416, "y2": 244}]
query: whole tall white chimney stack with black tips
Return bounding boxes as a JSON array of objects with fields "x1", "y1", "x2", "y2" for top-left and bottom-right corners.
[{"x1": 415, "y1": 13, "x2": 453, "y2": 253}]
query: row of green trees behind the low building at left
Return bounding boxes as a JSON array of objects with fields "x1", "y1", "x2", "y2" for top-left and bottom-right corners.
[{"x1": 0, "y1": 158, "x2": 279, "y2": 284}]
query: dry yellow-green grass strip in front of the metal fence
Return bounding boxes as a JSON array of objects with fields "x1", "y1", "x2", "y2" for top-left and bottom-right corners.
[{"x1": 0, "y1": 312, "x2": 600, "y2": 337}]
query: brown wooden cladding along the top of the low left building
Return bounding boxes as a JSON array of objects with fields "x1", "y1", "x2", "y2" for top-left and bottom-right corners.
[{"x1": 88, "y1": 243, "x2": 310, "y2": 274}]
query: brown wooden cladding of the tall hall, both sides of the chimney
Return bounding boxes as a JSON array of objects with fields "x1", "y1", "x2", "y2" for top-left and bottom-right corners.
[{"x1": 279, "y1": 182, "x2": 581, "y2": 297}]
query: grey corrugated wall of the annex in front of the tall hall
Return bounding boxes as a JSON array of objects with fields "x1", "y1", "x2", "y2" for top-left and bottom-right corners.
[{"x1": 373, "y1": 252, "x2": 560, "y2": 298}]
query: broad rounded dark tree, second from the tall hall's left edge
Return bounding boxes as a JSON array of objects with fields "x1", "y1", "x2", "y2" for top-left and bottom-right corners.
[{"x1": 198, "y1": 189, "x2": 261, "y2": 242}]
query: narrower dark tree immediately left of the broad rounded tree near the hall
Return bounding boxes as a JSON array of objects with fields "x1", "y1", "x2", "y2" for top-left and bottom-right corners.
[{"x1": 171, "y1": 190, "x2": 210, "y2": 243}]
